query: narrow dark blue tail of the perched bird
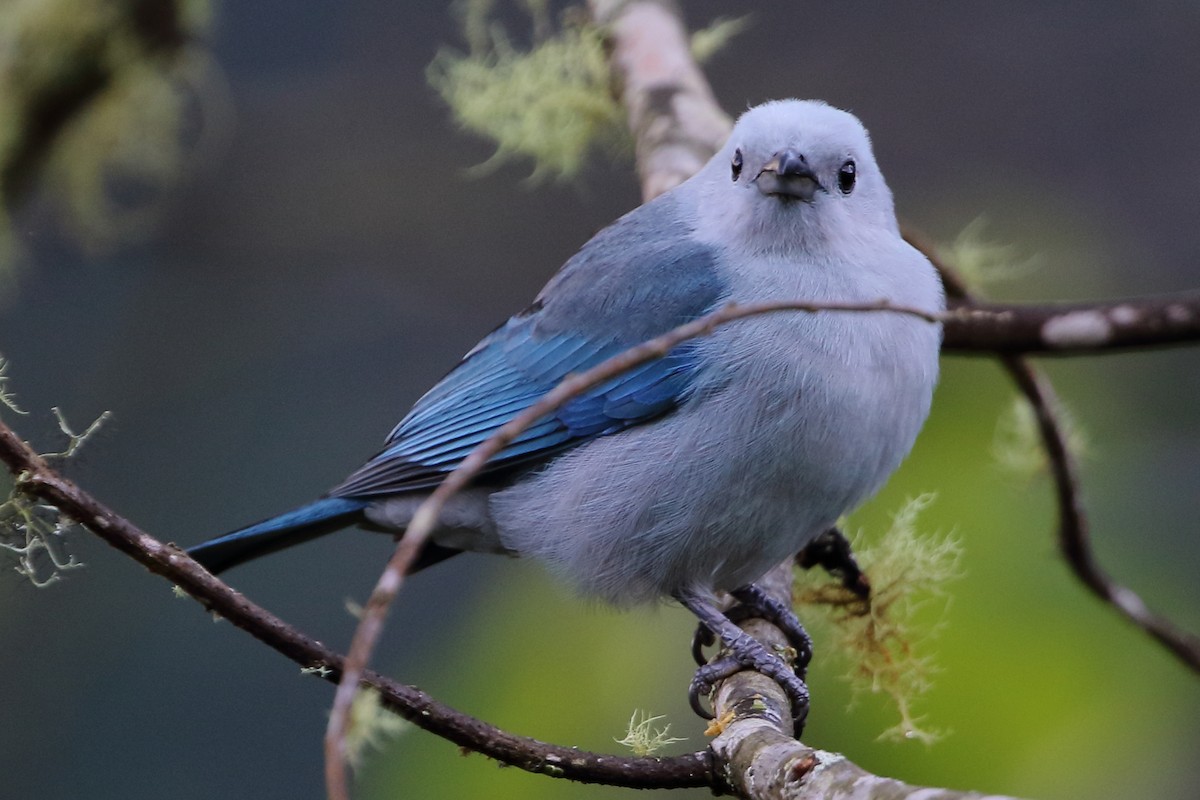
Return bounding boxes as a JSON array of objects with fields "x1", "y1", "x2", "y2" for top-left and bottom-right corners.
[{"x1": 187, "y1": 498, "x2": 368, "y2": 575}]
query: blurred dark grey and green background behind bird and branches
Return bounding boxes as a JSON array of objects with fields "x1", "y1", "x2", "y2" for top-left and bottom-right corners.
[{"x1": 0, "y1": 0, "x2": 1200, "y2": 800}]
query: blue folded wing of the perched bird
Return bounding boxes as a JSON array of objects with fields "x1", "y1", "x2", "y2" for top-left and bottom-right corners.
[{"x1": 331, "y1": 197, "x2": 724, "y2": 498}]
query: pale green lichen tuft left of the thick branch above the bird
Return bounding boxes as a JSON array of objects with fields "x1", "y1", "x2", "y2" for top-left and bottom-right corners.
[{"x1": 427, "y1": 0, "x2": 625, "y2": 179}]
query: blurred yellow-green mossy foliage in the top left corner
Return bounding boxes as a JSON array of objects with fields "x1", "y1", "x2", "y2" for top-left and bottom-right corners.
[{"x1": 0, "y1": 0, "x2": 212, "y2": 264}]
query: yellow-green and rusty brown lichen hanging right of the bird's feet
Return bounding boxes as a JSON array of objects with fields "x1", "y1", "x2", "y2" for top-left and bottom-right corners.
[{"x1": 794, "y1": 494, "x2": 962, "y2": 744}]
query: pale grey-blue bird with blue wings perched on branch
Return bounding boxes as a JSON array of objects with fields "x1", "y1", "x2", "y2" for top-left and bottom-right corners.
[{"x1": 188, "y1": 100, "x2": 944, "y2": 727}]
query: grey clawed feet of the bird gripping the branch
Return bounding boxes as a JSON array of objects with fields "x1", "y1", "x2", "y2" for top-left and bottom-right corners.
[{"x1": 677, "y1": 585, "x2": 812, "y2": 736}]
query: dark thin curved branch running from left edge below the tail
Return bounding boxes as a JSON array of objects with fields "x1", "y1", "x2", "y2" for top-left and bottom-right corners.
[{"x1": 0, "y1": 422, "x2": 722, "y2": 788}]
